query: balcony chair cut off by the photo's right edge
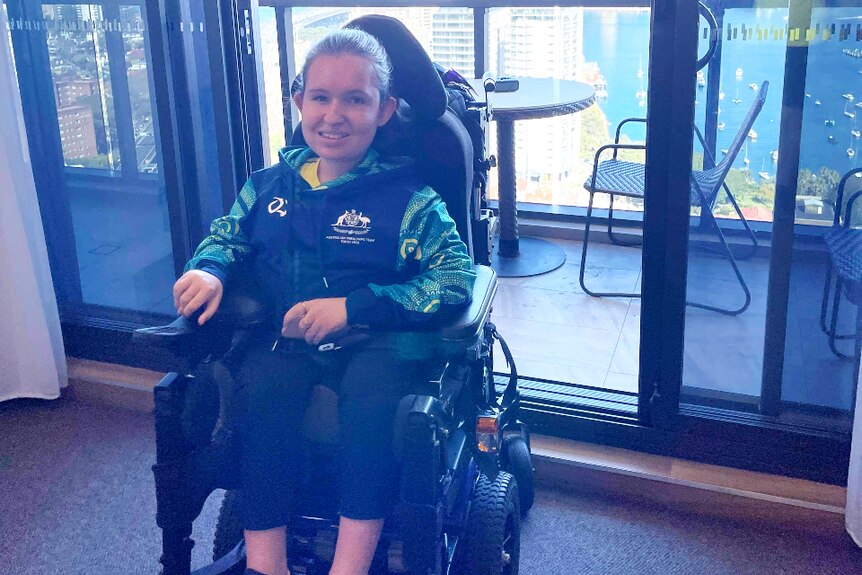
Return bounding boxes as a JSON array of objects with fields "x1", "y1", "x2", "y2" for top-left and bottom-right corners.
[{"x1": 820, "y1": 168, "x2": 862, "y2": 381}]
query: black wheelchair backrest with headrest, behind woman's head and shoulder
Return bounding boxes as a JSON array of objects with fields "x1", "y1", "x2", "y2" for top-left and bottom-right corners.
[{"x1": 291, "y1": 15, "x2": 482, "y2": 261}]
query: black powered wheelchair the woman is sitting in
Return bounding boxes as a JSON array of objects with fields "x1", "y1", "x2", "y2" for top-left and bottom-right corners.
[{"x1": 134, "y1": 16, "x2": 533, "y2": 575}]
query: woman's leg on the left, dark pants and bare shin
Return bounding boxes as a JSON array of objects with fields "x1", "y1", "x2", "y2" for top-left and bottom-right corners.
[{"x1": 240, "y1": 340, "x2": 319, "y2": 575}]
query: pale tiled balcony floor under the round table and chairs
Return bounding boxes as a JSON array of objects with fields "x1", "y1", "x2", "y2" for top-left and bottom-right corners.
[{"x1": 493, "y1": 239, "x2": 855, "y2": 416}]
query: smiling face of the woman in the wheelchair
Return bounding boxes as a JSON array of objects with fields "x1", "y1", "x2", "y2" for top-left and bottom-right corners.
[{"x1": 294, "y1": 54, "x2": 395, "y2": 182}]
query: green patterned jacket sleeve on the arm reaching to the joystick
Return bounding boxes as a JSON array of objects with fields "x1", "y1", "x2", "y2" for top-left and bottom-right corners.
[{"x1": 184, "y1": 180, "x2": 257, "y2": 283}]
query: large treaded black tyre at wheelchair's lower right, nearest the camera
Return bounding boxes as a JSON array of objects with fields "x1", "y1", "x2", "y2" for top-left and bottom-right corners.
[{"x1": 450, "y1": 471, "x2": 521, "y2": 575}]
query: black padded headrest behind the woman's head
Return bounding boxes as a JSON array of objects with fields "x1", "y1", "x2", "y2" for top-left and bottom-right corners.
[{"x1": 344, "y1": 14, "x2": 447, "y2": 120}]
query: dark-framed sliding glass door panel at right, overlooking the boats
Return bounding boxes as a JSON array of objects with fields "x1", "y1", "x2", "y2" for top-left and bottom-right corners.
[{"x1": 641, "y1": 1, "x2": 862, "y2": 478}]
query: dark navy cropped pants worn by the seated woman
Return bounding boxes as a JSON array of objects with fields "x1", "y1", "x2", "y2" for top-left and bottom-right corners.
[{"x1": 239, "y1": 333, "x2": 431, "y2": 530}]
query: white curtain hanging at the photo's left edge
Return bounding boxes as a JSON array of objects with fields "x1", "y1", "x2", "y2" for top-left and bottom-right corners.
[{"x1": 0, "y1": 10, "x2": 67, "y2": 401}]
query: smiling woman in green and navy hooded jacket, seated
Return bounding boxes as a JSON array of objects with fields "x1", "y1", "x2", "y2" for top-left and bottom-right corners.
[{"x1": 174, "y1": 29, "x2": 475, "y2": 575}]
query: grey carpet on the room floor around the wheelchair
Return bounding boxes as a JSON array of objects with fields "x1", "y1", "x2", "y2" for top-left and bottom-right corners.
[{"x1": 0, "y1": 398, "x2": 862, "y2": 575}]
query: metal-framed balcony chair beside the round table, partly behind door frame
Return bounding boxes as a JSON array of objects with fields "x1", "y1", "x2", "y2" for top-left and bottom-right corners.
[{"x1": 578, "y1": 82, "x2": 769, "y2": 315}]
